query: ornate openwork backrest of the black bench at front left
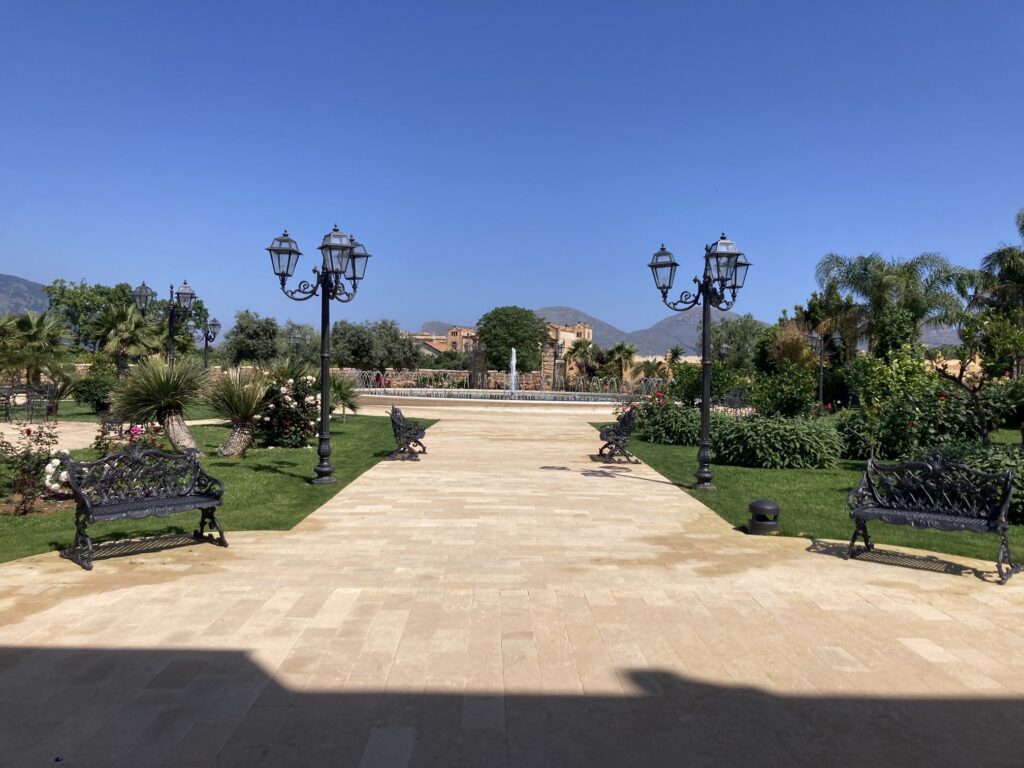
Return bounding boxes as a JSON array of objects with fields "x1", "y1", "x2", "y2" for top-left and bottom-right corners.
[{"x1": 66, "y1": 445, "x2": 220, "y2": 508}]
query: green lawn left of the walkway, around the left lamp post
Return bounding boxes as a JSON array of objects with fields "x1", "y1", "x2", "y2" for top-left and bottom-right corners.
[{"x1": 0, "y1": 414, "x2": 425, "y2": 562}]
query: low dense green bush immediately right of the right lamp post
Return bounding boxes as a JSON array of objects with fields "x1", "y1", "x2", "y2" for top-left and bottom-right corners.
[{"x1": 714, "y1": 416, "x2": 843, "y2": 469}]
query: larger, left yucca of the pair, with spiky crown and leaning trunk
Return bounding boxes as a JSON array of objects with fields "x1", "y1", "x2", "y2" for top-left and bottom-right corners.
[{"x1": 111, "y1": 357, "x2": 209, "y2": 451}]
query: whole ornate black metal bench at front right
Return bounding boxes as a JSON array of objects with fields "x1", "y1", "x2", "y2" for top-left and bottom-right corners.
[{"x1": 846, "y1": 455, "x2": 1024, "y2": 584}]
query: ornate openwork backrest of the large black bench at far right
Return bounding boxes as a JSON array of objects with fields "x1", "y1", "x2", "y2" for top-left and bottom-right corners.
[{"x1": 851, "y1": 455, "x2": 1013, "y2": 520}]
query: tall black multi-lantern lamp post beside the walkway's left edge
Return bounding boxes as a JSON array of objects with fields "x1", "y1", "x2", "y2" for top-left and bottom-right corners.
[{"x1": 266, "y1": 224, "x2": 370, "y2": 483}]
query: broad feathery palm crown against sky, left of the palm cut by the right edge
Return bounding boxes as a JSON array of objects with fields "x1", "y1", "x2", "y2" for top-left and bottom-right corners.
[{"x1": 815, "y1": 253, "x2": 964, "y2": 344}]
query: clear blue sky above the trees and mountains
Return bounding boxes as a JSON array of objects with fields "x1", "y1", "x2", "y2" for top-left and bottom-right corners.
[{"x1": 0, "y1": 0, "x2": 1024, "y2": 331}]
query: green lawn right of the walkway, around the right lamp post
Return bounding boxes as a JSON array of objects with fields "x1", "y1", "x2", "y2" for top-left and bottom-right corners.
[{"x1": 618, "y1": 438, "x2": 1024, "y2": 562}]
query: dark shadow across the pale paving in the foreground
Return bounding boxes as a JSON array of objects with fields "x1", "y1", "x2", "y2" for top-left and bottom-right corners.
[{"x1": 0, "y1": 647, "x2": 1024, "y2": 768}]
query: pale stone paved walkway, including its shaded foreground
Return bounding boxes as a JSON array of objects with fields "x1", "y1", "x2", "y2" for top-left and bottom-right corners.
[{"x1": 0, "y1": 406, "x2": 1024, "y2": 768}]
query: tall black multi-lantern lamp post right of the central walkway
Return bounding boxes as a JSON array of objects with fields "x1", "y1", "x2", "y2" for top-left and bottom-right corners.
[{"x1": 647, "y1": 232, "x2": 751, "y2": 490}]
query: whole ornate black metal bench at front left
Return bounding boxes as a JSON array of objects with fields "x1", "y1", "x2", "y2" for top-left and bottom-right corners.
[{"x1": 60, "y1": 445, "x2": 227, "y2": 570}]
